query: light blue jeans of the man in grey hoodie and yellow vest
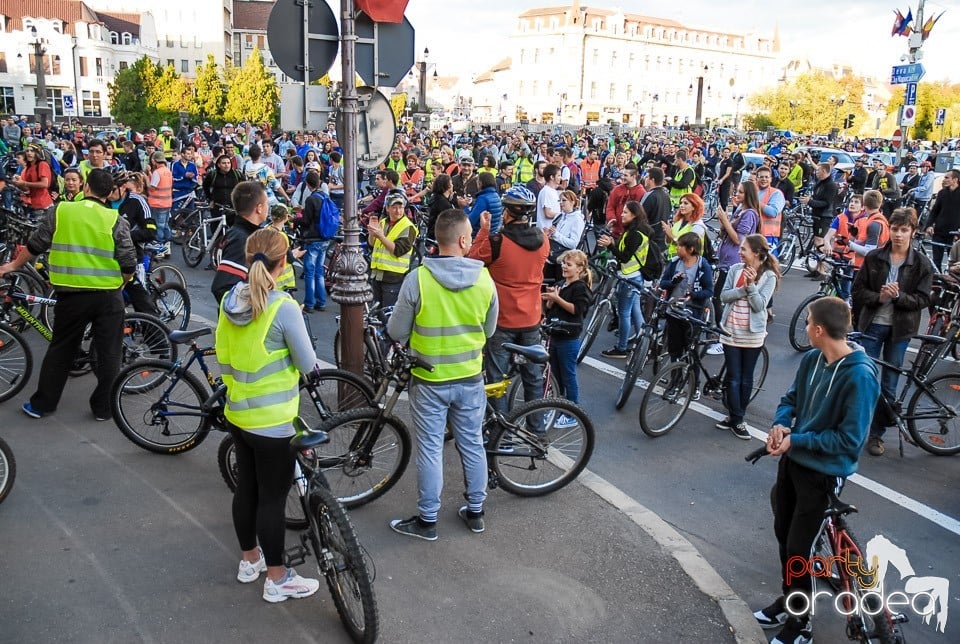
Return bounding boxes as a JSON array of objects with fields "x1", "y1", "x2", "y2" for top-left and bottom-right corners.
[{"x1": 409, "y1": 379, "x2": 487, "y2": 521}]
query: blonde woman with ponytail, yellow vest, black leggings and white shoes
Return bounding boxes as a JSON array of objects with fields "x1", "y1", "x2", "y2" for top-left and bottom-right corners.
[{"x1": 216, "y1": 228, "x2": 320, "y2": 602}]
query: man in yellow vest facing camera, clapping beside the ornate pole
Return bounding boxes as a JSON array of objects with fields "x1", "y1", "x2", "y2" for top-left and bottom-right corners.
[{"x1": 367, "y1": 190, "x2": 417, "y2": 307}]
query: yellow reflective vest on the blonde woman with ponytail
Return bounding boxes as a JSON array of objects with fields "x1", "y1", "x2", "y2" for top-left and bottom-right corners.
[{"x1": 216, "y1": 294, "x2": 300, "y2": 429}]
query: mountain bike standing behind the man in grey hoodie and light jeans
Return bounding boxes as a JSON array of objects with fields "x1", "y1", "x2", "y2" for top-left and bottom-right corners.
[{"x1": 318, "y1": 343, "x2": 594, "y2": 508}]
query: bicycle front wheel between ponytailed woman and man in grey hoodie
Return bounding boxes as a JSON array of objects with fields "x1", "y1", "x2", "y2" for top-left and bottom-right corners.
[{"x1": 314, "y1": 407, "x2": 410, "y2": 508}]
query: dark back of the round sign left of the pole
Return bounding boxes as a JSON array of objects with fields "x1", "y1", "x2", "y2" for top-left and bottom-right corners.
[{"x1": 267, "y1": 0, "x2": 340, "y2": 82}]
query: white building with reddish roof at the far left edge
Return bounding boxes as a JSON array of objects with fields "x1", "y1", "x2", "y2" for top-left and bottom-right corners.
[{"x1": 0, "y1": 0, "x2": 158, "y2": 123}]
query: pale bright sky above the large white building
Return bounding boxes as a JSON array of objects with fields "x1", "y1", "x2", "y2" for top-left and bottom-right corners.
[{"x1": 406, "y1": 0, "x2": 960, "y2": 82}]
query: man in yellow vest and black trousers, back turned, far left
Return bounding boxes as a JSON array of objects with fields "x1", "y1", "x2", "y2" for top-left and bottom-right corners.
[{"x1": 0, "y1": 168, "x2": 137, "y2": 420}]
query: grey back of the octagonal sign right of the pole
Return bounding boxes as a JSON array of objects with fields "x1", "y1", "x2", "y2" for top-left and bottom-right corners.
[{"x1": 356, "y1": 13, "x2": 414, "y2": 87}]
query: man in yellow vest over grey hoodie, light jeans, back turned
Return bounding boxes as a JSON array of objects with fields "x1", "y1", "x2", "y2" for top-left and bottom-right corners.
[{"x1": 387, "y1": 209, "x2": 498, "y2": 541}]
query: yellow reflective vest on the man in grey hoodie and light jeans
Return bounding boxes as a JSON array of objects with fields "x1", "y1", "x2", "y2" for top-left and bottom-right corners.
[{"x1": 410, "y1": 266, "x2": 494, "y2": 382}]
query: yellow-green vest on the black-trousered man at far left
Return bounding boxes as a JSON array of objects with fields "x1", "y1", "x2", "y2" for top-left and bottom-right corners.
[{"x1": 50, "y1": 199, "x2": 123, "y2": 291}]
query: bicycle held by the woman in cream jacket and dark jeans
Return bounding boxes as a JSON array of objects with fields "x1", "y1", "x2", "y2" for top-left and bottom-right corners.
[{"x1": 640, "y1": 303, "x2": 770, "y2": 438}]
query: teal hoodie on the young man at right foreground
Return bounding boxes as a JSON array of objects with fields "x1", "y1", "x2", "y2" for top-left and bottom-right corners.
[{"x1": 773, "y1": 345, "x2": 880, "y2": 477}]
